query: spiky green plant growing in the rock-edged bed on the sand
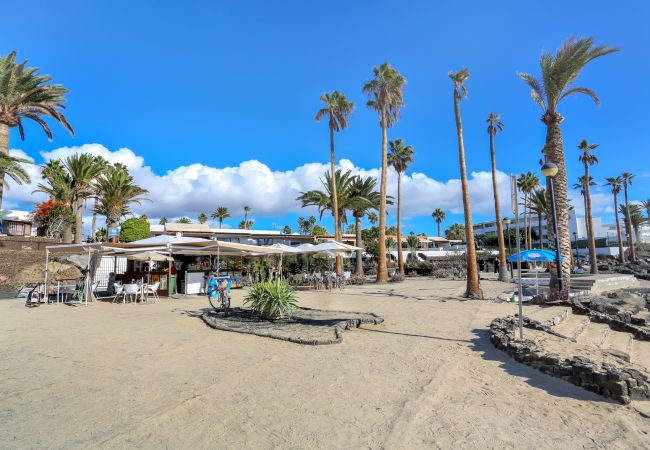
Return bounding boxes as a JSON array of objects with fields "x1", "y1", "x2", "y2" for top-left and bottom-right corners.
[{"x1": 244, "y1": 280, "x2": 298, "y2": 320}]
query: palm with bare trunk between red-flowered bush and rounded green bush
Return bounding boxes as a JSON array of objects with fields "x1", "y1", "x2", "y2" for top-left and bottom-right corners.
[{"x1": 63, "y1": 153, "x2": 106, "y2": 244}]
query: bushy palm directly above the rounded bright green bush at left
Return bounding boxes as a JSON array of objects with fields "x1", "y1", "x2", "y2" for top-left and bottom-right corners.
[{"x1": 94, "y1": 165, "x2": 149, "y2": 239}]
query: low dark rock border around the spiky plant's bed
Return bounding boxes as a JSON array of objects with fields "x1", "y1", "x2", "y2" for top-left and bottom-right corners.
[{"x1": 201, "y1": 307, "x2": 384, "y2": 345}]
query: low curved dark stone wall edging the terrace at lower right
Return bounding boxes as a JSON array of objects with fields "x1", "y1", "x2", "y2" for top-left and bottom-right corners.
[{"x1": 490, "y1": 316, "x2": 650, "y2": 404}]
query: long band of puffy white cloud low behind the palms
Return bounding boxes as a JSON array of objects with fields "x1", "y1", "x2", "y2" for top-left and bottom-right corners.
[{"x1": 6, "y1": 144, "x2": 510, "y2": 219}]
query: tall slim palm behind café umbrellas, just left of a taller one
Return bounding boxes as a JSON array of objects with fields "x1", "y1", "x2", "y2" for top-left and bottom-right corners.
[{"x1": 316, "y1": 91, "x2": 354, "y2": 274}]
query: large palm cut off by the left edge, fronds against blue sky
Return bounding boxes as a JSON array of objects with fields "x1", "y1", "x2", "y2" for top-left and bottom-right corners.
[{"x1": 0, "y1": 52, "x2": 74, "y2": 209}]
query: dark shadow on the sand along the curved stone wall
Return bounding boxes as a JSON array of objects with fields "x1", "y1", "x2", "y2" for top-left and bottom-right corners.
[{"x1": 469, "y1": 329, "x2": 618, "y2": 405}]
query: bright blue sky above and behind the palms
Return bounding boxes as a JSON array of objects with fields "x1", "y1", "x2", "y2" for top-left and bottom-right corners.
[{"x1": 0, "y1": 0, "x2": 650, "y2": 236}]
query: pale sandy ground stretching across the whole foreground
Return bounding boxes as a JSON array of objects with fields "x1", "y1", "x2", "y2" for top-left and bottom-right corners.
[{"x1": 0, "y1": 279, "x2": 650, "y2": 449}]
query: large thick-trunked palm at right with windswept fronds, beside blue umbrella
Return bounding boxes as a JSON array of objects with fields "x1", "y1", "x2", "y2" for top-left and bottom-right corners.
[{"x1": 519, "y1": 38, "x2": 618, "y2": 294}]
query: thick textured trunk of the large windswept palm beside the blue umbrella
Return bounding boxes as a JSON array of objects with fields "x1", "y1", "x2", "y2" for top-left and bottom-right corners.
[{"x1": 542, "y1": 113, "x2": 571, "y2": 296}]
